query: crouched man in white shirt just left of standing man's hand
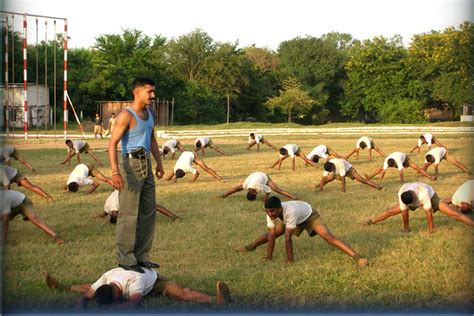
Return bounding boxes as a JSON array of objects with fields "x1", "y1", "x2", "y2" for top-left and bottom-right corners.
[{"x1": 64, "y1": 163, "x2": 113, "y2": 194}]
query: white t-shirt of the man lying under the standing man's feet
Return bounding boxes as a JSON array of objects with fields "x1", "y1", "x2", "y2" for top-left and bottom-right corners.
[{"x1": 91, "y1": 268, "x2": 158, "y2": 300}]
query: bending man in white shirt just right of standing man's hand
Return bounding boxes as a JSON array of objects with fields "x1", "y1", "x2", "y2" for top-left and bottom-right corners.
[{"x1": 166, "y1": 151, "x2": 225, "y2": 183}]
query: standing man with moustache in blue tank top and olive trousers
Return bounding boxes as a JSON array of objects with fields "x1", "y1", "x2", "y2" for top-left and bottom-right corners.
[{"x1": 108, "y1": 78, "x2": 164, "y2": 273}]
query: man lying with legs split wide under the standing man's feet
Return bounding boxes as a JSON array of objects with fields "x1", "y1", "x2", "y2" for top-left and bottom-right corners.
[{"x1": 45, "y1": 268, "x2": 231, "y2": 308}]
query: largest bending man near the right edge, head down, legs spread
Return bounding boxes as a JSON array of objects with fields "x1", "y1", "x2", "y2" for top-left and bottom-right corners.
[{"x1": 364, "y1": 182, "x2": 474, "y2": 233}]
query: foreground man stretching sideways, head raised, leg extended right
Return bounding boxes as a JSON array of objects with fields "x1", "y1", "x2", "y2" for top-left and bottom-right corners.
[{"x1": 235, "y1": 196, "x2": 369, "y2": 267}]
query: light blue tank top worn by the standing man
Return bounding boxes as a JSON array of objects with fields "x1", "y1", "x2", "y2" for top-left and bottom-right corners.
[{"x1": 122, "y1": 108, "x2": 153, "y2": 154}]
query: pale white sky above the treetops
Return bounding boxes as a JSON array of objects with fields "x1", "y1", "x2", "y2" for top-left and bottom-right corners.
[{"x1": 0, "y1": 0, "x2": 474, "y2": 50}]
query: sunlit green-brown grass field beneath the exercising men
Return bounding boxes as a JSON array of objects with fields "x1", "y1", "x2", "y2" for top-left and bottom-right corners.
[{"x1": 2, "y1": 131, "x2": 474, "y2": 313}]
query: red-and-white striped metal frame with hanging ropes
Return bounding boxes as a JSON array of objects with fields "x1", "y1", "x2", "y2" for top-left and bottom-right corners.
[{"x1": 0, "y1": 11, "x2": 68, "y2": 140}]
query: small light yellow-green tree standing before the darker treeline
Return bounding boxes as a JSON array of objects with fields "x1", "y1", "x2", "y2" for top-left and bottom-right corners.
[{"x1": 265, "y1": 77, "x2": 315, "y2": 123}]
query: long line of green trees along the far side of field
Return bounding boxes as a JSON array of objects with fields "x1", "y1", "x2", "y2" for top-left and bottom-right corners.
[{"x1": 1, "y1": 21, "x2": 474, "y2": 124}]
